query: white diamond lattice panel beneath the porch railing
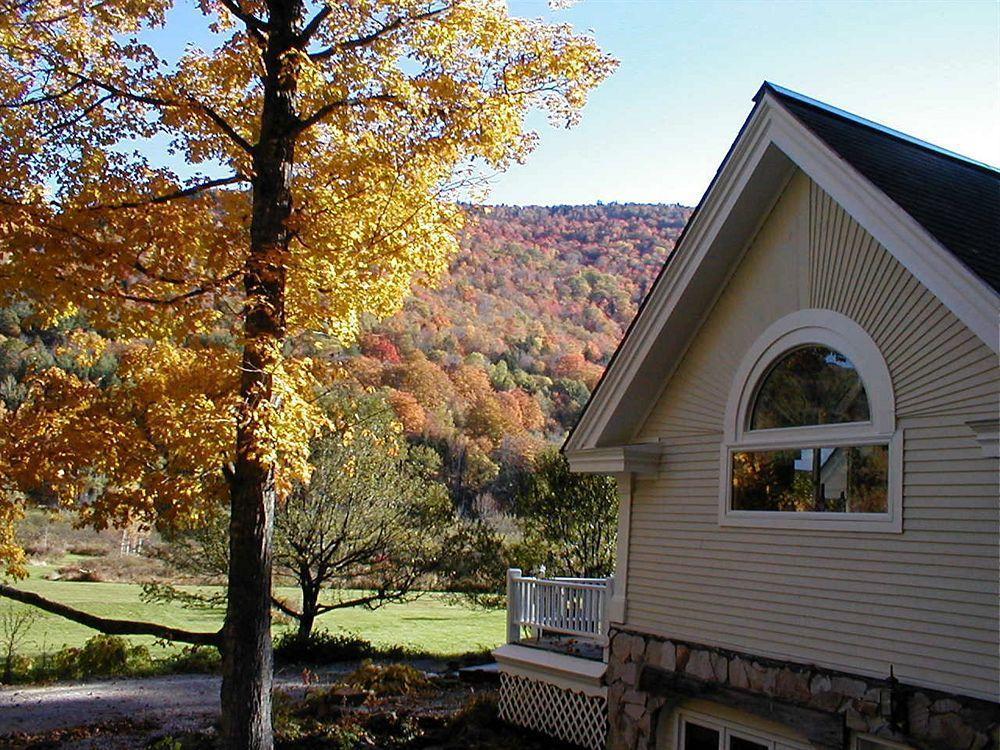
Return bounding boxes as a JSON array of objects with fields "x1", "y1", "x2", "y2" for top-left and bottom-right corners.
[{"x1": 500, "y1": 672, "x2": 608, "y2": 750}]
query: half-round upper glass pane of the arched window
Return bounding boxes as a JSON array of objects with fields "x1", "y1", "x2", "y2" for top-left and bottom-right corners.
[{"x1": 749, "y1": 345, "x2": 869, "y2": 430}]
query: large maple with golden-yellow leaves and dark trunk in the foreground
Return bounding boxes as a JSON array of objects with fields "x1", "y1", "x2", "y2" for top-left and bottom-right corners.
[{"x1": 0, "y1": 0, "x2": 614, "y2": 748}]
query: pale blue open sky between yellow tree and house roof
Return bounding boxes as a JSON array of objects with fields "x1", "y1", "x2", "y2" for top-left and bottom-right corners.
[{"x1": 490, "y1": 0, "x2": 1000, "y2": 205}]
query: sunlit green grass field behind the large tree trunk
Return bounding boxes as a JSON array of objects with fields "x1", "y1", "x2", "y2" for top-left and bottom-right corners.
[{"x1": 0, "y1": 566, "x2": 505, "y2": 656}]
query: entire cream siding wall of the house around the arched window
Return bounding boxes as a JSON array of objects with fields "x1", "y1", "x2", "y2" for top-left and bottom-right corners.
[{"x1": 626, "y1": 173, "x2": 1000, "y2": 700}]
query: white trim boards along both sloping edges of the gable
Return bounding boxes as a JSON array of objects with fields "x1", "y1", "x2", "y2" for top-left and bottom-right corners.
[{"x1": 565, "y1": 92, "x2": 1000, "y2": 456}]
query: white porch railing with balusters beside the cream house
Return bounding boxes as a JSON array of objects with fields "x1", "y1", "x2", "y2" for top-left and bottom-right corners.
[{"x1": 507, "y1": 568, "x2": 614, "y2": 646}]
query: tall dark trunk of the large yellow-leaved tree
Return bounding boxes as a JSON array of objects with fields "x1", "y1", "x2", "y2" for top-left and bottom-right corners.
[{"x1": 222, "y1": 0, "x2": 303, "y2": 750}]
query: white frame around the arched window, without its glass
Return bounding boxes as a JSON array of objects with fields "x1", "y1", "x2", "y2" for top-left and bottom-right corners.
[{"x1": 719, "y1": 309, "x2": 903, "y2": 533}]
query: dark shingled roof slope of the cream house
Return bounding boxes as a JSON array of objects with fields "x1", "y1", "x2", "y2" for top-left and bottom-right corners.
[{"x1": 754, "y1": 83, "x2": 1000, "y2": 291}]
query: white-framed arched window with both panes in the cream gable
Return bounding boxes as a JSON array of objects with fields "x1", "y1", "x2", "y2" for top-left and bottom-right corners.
[{"x1": 720, "y1": 310, "x2": 902, "y2": 531}]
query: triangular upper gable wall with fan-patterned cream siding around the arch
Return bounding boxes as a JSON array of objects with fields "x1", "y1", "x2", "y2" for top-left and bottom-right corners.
[{"x1": 632, "y1": 172, "x2": 997, "y2": 443}]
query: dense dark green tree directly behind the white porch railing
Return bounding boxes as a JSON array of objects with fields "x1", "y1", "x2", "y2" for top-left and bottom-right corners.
[{"x1": 515, "y1": 449, "x2": 618, "y2": 578}]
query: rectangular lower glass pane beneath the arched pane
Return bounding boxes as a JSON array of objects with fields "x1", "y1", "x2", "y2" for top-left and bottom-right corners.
[{"x1": 732, "y1": 445, "x2": 889, "y2": 513}]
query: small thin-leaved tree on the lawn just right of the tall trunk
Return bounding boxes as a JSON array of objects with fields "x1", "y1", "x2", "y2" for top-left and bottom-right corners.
[{"x1": 274, "y1": 398, "x2": 452, "y2": 639}]
